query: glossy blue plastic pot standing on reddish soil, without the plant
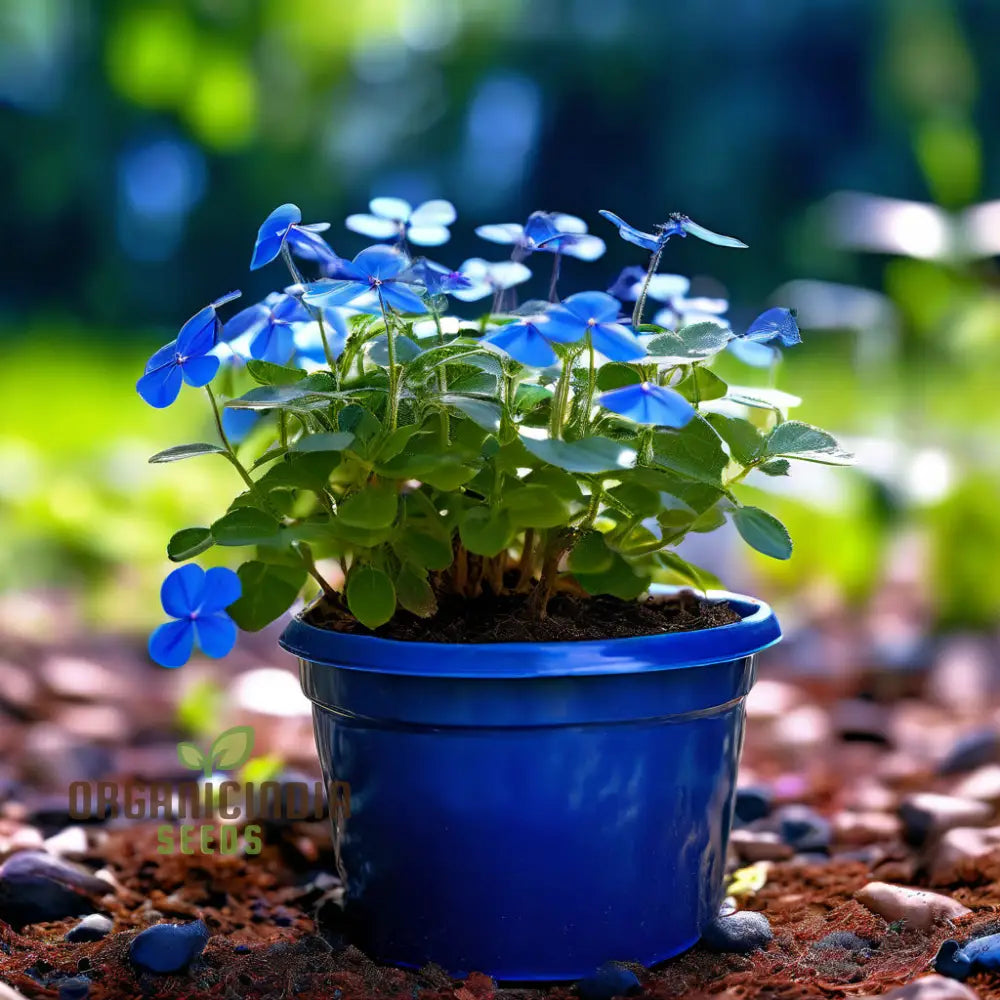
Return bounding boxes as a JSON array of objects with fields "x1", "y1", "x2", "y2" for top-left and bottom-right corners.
[{"x1": 281, "y1": 594, "x2": 781, "y2": 980}]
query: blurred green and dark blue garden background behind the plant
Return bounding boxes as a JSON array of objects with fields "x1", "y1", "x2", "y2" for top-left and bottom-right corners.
[{"x1": 0, "y1": 0, "x2": 1000, "y2": 626}]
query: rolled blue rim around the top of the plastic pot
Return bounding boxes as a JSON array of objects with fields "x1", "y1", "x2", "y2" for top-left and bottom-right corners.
[{"x1": 278, "y1": 584, "x2": 781, "y2": 679}]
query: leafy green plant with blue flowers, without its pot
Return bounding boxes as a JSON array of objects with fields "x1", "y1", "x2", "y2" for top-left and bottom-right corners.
[{"x1": 137, "y1": 198, "x2": 850, "y2": 666}]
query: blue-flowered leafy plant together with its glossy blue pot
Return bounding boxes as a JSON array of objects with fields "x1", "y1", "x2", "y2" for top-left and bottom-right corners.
[{"x1": 138, "y1": 198, "x2": 848, "y2": 980}]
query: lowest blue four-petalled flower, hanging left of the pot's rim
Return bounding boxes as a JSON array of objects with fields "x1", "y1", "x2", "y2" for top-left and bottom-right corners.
[{"x1": 149, "y1": 563, "x2": 243, "y2": 667}]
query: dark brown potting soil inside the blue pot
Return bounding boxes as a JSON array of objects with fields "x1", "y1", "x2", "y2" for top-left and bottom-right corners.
[{"x1": 306, "y1": 591, "x2": 740, "y2": 643}]
